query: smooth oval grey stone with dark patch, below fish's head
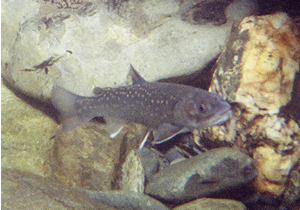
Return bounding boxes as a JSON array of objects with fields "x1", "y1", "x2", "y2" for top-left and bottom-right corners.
[{"x1": 145, "y1": 148, "x2": 257, "y2": 203}]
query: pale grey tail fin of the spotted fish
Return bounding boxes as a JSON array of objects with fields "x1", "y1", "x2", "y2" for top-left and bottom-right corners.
[{"x1": 51, "y1": 86, "x2": 93, "y2": 133}]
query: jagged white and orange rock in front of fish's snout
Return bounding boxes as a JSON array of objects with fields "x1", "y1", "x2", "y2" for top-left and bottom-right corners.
[{"x1": 201, "y1": 13, "x2": 300, "y2": 195}]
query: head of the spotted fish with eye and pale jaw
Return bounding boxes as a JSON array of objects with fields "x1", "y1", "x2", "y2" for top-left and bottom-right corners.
[{"x1": 173, "y1": 89, "x2": 232, "y2": 129}]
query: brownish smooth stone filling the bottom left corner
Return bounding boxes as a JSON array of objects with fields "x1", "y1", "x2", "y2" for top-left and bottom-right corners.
[{"x1": 1, "y1": 168, "x2": 115, "y2": 210}]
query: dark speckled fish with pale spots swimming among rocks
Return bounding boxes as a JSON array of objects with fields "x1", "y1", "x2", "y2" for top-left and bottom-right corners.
[{"x1": 51, "y1": 67, "x2": 232, "y2": 144}]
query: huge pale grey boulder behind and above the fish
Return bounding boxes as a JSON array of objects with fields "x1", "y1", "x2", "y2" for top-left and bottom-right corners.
[{"x1": 2, "y1": 0, "x2": 253, "y2": 100}]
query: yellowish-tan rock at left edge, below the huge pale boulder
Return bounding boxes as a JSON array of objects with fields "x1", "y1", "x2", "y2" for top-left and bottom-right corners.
[{"x1": 1, "y1": 82, "x2": 57, "y2": 176}]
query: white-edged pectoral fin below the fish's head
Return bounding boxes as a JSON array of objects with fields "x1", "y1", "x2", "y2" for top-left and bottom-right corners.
[{"x1": 152, "y1": 124, "x2": 189, "y2": 145}]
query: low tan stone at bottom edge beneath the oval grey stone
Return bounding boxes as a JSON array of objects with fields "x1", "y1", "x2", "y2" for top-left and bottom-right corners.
[{"x1": 173, "y1": 198, "x2": 247, "y2": 210}]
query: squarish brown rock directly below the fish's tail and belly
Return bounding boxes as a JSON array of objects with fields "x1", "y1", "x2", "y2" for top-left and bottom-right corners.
[{"x1": 51, "y1": 122, "x2": 124, "y2": 190}]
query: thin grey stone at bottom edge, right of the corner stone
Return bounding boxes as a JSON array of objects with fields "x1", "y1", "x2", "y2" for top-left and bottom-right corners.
[{"x1": 81, "y1": 190, "x2": 169, "y2": 210}]
